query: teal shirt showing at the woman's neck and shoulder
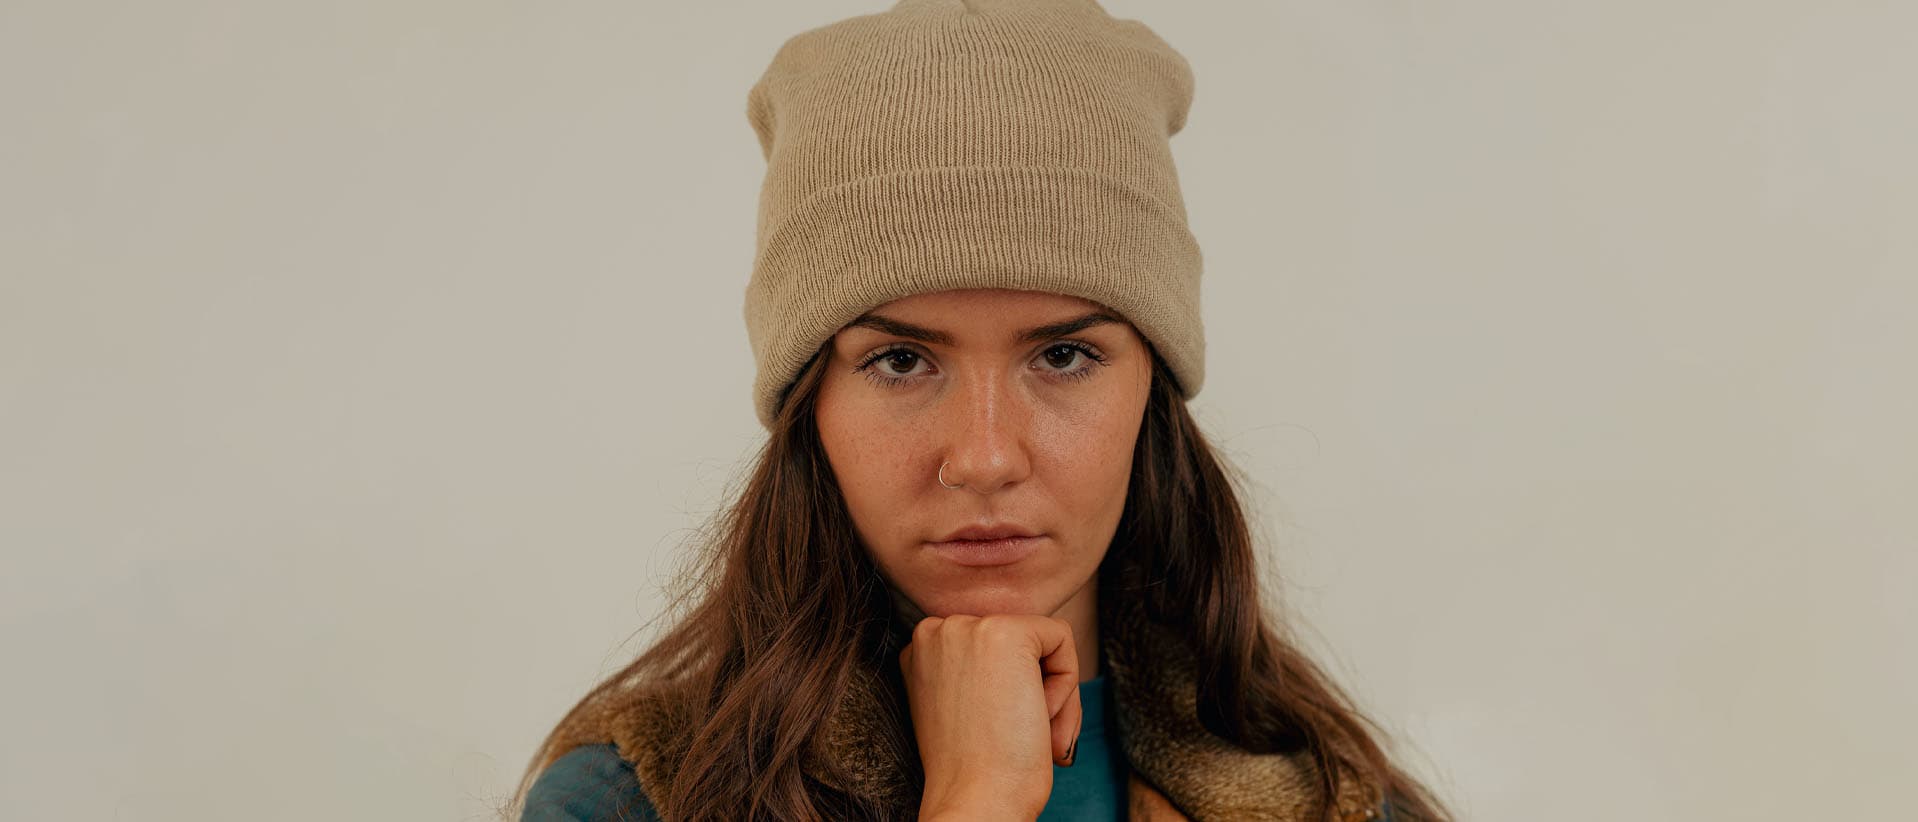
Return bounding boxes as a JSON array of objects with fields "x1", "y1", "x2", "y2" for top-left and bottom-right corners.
[{"x1": 520, "y1": 674, "x2": 1391, "y2": 822}]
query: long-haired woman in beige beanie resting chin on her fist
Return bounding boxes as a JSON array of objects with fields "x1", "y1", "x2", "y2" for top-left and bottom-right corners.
[{"x1": 514, "y1": 0, "x2": 1444, "y2": 822}]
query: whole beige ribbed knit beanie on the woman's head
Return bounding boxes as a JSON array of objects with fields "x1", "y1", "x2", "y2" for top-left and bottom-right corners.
[{"x1": 746, "y1": 0, "x2": 1205, "y2": 429}]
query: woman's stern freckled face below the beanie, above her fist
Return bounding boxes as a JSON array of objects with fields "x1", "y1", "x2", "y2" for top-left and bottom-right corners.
[{"x1": 815, "y1": 289, "x2": 1153, "y2": 617}]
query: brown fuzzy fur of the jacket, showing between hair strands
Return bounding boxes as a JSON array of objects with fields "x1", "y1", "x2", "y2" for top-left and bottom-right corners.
[{"x1": 562, "y1": 578, "x2": 1385, "y2": 822}]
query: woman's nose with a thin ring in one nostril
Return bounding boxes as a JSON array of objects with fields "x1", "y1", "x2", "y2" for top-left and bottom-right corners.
[{"x1": 926, "y1": 370, "x2": 1032, "y2": 494}]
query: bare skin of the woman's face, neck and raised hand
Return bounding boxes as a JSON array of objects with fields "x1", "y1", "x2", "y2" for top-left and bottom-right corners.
[{"x1": 815, "y1": 289, "x2": 1151, "y2": 818}]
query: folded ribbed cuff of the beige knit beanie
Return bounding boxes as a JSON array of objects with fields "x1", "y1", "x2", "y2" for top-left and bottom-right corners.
[{"x1": 746, "y1": 165, "x2": 1205, "y2": 429}]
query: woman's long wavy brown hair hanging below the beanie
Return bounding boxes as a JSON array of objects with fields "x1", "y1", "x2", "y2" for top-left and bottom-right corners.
[{"x1": 508, "y1": 341, "x2": 1450, "y2": 822}]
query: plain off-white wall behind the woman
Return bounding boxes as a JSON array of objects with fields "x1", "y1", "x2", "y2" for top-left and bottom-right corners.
[{"x1": 0, "y1": 0, "x2": 1918, "y2": 822}]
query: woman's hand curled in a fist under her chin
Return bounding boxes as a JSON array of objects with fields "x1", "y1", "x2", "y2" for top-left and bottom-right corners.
[{"x1": 900, "y1": 613, "x2": 1084, "y2": 820}]
